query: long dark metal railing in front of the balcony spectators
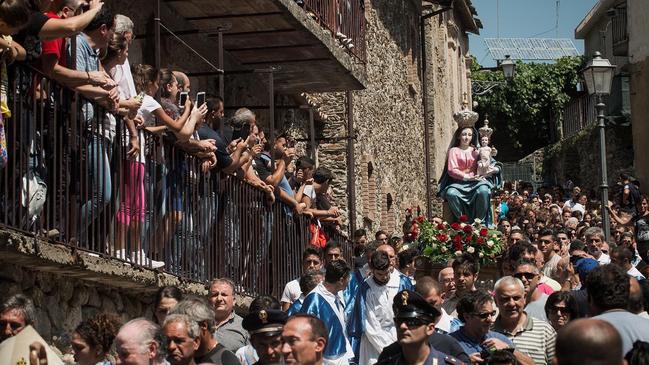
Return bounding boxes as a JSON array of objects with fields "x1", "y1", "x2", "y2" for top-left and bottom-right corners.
[{"x1": 0, "y1": 66, "x2": 344, "y2": 296}]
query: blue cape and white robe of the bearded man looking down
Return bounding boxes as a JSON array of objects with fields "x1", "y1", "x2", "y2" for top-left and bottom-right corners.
[{"x1": 347, "y1": 270, "x2": 414, "y2": 365}]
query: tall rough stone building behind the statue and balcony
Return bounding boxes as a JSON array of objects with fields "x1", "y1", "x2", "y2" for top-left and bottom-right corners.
[{"x1": 313, "y1": 0, "x2": 481, "y2": 235}]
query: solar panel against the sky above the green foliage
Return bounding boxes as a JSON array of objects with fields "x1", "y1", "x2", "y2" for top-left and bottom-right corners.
[{"x1": 484, "y1": 38, "x2": 579, "y2": 61}]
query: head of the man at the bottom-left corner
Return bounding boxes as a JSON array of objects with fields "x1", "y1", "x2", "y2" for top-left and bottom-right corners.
[{"x1": 0, "y1": 294, "x2": 36, "y2": 342}]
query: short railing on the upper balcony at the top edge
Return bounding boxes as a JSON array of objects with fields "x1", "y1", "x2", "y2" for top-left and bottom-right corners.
[{"x1": 304, "y1": 0, "x2": 366, "y2": 62}]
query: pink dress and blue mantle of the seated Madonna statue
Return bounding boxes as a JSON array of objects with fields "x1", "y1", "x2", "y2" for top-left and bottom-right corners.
[{"x1": 438, "y1": 128, "x2": 502, "y2": 226}]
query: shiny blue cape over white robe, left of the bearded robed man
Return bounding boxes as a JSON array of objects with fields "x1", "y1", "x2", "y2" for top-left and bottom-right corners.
[{"x1": 300, "y1": 284, "x2": 354, "y2": 365}]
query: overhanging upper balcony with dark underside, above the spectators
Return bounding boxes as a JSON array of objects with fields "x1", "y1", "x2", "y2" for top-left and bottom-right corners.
[{"x1": 162, "y1": 0, "x2": 365, "y2": 93}]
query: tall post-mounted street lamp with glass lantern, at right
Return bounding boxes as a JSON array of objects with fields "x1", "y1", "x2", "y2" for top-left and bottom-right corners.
[{"x1": 581, "y1": 52, "x2": 616, "y2": 241}]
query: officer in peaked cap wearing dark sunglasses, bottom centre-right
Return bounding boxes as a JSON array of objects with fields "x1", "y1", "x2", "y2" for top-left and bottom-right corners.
[{"x1": 377, "y1": 290, "x2": 464, "y2": 365}]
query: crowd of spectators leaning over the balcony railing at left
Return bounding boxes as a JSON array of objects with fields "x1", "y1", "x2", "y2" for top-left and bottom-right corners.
[{"x1": 0, "y1": 0, "x2": 342, "y2": 272}]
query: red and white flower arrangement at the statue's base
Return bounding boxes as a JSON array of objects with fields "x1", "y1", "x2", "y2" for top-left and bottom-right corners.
[{"x1": 413, "y1": 215, "x2": 504, "y2": 265}]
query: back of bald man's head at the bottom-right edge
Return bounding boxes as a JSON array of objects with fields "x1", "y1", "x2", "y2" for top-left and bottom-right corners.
[{"x1": 552, "y1": 318, "x2": 624, "y2": 365}]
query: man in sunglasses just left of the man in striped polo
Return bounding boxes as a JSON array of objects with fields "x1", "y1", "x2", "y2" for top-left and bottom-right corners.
[{"x1": 451, "y1": 290, "x2": 531, "y2": 364}]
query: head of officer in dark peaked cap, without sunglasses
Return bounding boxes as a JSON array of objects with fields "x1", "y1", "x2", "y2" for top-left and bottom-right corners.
[{"x1": 242, "y1": 309, "x2": 288, "y2": 365}]
